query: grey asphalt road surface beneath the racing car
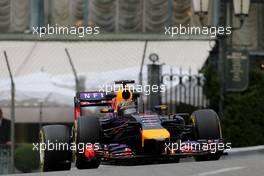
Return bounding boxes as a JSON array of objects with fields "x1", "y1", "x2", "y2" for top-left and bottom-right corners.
[{"x1": 10, "y1": 152, "x2": 264, "y2": 176}]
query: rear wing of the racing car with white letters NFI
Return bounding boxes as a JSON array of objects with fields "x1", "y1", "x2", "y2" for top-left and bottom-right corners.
[{"x1": 74, "y1": 91, "x2": 112, "y2": 107}]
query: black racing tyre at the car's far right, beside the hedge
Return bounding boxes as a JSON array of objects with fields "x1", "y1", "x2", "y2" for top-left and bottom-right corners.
[{"x1": 191, "y1": 109, "x2": 223, "y2": 161}]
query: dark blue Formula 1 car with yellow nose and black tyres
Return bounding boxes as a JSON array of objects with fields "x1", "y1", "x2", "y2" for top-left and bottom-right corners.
[{"x1": 40, "y1": 81, "x2": 224, "y2": 171}]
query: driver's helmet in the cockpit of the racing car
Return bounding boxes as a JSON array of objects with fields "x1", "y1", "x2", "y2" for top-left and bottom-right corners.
[{"x1": 118, "y1": 100, "x2": 137, "y2": 115}]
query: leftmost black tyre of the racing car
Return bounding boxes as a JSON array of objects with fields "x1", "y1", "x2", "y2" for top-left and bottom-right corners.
[{"x1": 39, "y1": 125, "x2": 71, "y2": 172}]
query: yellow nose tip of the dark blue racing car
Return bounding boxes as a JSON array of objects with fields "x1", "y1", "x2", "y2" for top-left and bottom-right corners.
[{"x1": 141, "y1": 128, "x2": 170, "y2": 147}]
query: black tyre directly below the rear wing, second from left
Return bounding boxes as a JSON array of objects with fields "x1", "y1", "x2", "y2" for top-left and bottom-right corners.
[{"x1": 75, "y1": 117, "x2": 101, "y2": 169}]
